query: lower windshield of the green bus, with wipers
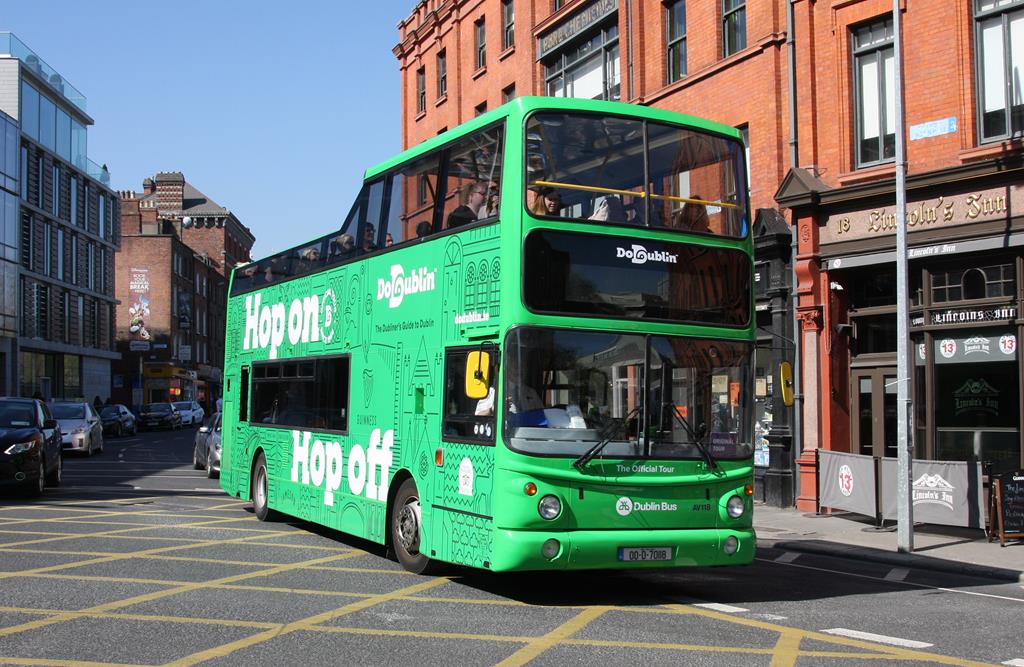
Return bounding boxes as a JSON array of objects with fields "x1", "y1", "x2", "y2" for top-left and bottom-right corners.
[{"x1": 504, "y1": 328, "x2": 753, "y2": 459}]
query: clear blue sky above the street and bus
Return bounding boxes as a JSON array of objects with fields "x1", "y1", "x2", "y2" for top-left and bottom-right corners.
[{"x1": 0, "y1": 0, "x2": 416, "y2": 256}]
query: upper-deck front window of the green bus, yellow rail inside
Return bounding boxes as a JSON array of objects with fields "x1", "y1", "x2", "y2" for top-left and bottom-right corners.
[{"x1": 525, "y1": 113, "x2": 750, "y2": 238}]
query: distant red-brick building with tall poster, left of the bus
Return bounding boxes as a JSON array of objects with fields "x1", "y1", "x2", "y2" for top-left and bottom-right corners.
[{"x1": 114, "y1": 172, "x2": 255, "y2": 408}]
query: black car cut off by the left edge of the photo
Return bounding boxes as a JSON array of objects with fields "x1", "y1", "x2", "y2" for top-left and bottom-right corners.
[{"x1": 0, "y1": 398, "x2": 63, "y2": 496}]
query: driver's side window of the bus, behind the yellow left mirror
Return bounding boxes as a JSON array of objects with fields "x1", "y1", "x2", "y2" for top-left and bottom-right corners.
[{"x1": 441, "y1": 346, "x2": 498, "y2": 443}]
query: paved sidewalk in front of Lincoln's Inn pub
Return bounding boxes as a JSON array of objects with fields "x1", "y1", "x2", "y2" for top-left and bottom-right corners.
[{"x1": 754, "y1": 503, "x2": 1024, "y2": 584}]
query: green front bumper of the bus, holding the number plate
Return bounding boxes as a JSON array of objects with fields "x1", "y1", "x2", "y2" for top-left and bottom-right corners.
[{"x1": 490, "y1": 528, "x2": 757, "y2": 572}]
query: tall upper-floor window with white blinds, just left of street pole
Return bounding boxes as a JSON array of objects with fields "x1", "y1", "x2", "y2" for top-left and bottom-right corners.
[{"x1": 853, "y1": 18, "x2": 896, "y2": 167}]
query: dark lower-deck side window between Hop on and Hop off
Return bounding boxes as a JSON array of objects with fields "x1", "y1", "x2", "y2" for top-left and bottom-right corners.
[{"x1": 249, "y1": 357, "x2": 350, "y2": 432}]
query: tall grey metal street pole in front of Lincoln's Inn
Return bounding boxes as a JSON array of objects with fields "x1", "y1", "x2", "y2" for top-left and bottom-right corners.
[{"x1": 893, "y1": 0, "x2": 913, "y2": 553}]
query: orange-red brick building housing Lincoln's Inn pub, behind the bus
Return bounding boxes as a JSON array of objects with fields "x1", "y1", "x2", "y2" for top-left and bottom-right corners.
[{"x1": 394, "y1": 0, "x2": 1024, "y2": 509}]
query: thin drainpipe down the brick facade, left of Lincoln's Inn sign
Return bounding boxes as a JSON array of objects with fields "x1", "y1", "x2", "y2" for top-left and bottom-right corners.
[{"x1": 785, "y1": 0, "x2": 804, "y2": 500}]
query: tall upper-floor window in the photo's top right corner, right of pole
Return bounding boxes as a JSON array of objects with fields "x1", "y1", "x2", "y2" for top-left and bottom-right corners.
[{"x1": 974, "y1": 0, "x2": 1024, "y2": 141}]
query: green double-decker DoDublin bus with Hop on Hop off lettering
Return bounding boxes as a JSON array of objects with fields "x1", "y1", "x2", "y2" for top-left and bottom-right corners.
[{"x1": 220, "y1": 97, "x2": 755, "y2": 573}]
